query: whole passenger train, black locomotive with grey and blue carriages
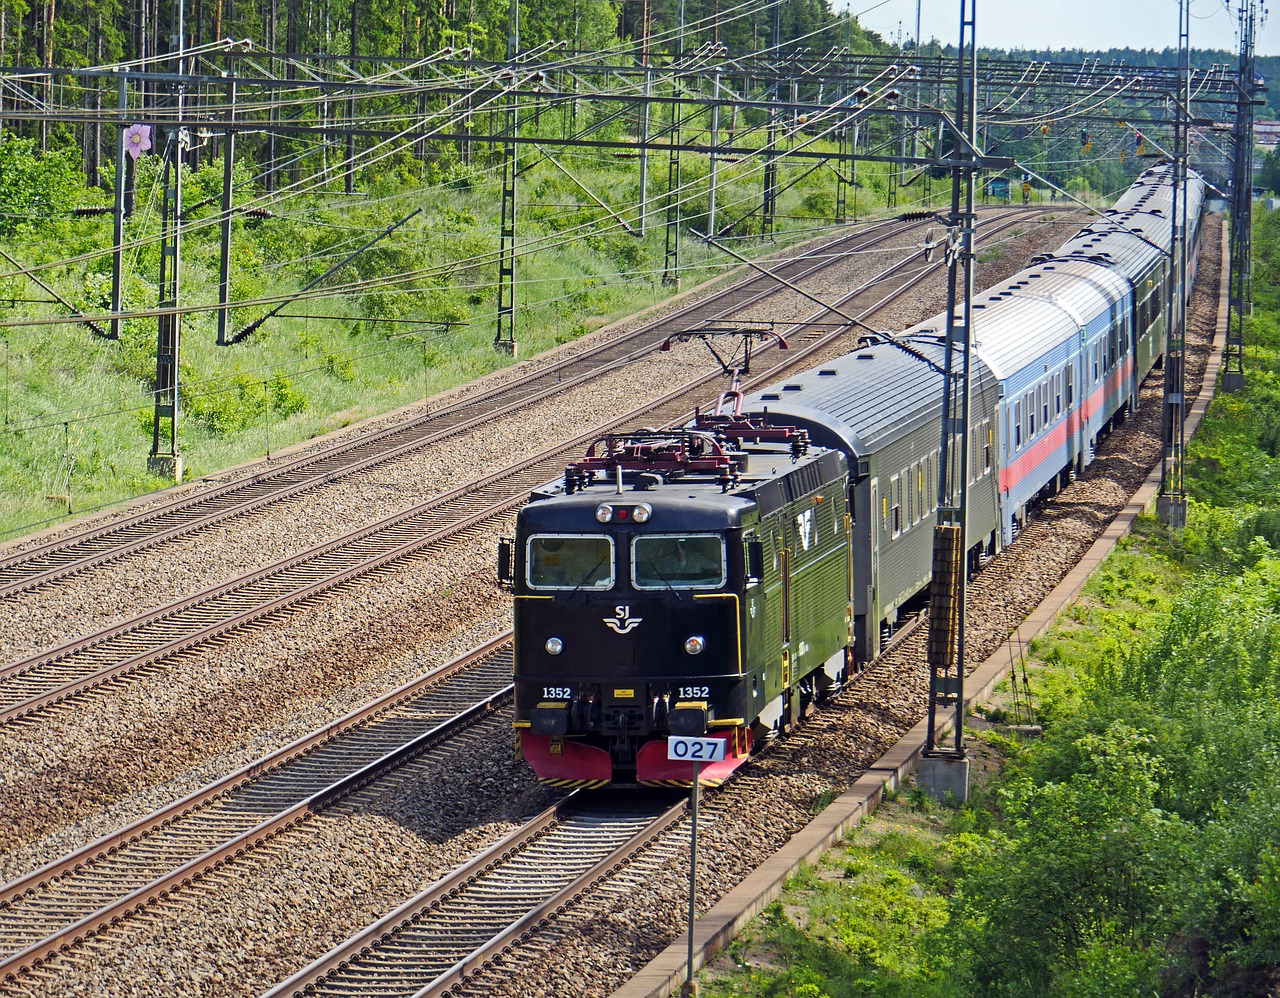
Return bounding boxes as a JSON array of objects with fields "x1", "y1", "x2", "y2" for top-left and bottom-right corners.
[{"x1": 499, "y1": 164, "x2": 1204, "y2": 787}]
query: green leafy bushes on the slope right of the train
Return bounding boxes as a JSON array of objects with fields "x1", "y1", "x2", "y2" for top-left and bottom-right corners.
[{"x1": 704, "y1": 212, "x2": 1280, "y2": 998}]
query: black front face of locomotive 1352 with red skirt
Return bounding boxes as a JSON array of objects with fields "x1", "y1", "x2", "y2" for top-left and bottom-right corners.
[{"x1": 512, "y1": 486, "x2": 754, "y2": 786}]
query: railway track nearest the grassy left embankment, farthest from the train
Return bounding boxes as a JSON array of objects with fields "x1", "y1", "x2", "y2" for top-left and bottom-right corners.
[{"x1": 0, "y1": 209, "x2": 1028, "y2": 598}]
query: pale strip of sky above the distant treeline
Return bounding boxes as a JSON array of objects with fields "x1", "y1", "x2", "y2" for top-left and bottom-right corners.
[{"x1": 849, "y1": 0, "x2": 1280, "y2": 55}]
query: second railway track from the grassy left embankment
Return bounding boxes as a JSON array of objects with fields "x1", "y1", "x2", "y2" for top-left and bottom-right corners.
[{"x1": 0, "y1": 205, "x2": 1044, "y2": 724}]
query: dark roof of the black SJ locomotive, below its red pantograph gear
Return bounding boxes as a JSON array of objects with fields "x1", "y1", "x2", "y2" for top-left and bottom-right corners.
[{"x1": 520, "y1": 445, "x2": 847, "y2": 534}]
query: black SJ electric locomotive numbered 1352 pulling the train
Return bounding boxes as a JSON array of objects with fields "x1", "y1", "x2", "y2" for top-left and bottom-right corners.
[{"x1": 499, "y1": 404, "x2": 852, "y2": 787}]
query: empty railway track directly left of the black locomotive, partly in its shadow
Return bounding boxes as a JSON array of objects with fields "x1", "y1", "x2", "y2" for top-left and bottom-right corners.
[{"x1": 0, "y1": 633, "x2": 511, "y2": 980}]
